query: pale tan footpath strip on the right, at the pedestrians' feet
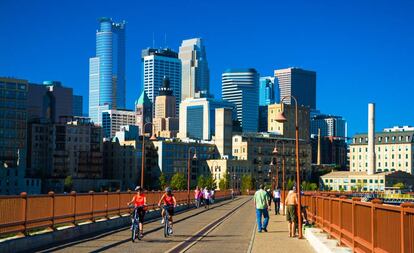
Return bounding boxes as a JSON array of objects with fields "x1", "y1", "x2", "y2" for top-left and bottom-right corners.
[{"x1": 251, "y1": 210, "x2": 315, "y2": 253}]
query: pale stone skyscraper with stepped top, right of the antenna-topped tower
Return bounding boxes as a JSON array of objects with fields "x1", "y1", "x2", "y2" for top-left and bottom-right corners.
[{"x1": 178, "y1": 38, "x2": 210, "y2": 101}]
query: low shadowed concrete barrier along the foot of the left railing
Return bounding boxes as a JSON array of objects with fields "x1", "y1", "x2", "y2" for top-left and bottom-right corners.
[{"x1": 0, "y1": 197, "x2": 231, "y2": 253}]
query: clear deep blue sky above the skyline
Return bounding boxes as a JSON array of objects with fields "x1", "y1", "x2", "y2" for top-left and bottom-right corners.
[{"x1": 0, "y1": 0, "x2": 414, "y2": 135}]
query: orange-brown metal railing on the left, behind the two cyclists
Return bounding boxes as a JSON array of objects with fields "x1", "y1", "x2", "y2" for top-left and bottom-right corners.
[{"x1": 0, "y1": 190, "x2": 231, "y2": 236}]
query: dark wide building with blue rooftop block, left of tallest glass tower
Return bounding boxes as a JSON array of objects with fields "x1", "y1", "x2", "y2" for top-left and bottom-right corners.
[{"x1": 27, "y1": 81, "x2": 74, "y2": 122}]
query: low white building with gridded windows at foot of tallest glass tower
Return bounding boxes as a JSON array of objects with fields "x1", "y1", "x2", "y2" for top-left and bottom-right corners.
[{"x1": 102, "y1": 110, "x2": 136, "y2": 138}]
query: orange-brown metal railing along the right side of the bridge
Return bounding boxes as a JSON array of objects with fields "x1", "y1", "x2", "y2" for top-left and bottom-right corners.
[{"x1": 302, "y1": 193, "x2": 414, "y2": 253}]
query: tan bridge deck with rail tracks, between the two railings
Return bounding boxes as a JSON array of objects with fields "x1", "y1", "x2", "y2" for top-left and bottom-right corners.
[{"x1": 36, "y1": 197, "x2": 312, "y2": 253}]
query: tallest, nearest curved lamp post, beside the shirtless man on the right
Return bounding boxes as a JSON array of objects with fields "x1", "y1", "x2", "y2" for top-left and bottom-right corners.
[{"x1": 276, "y1": 96, "x2": 303, "y2": 239}]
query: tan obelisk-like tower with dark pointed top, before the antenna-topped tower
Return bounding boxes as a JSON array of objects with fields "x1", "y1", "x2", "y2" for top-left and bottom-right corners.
[{"x1": 152, "y1": 77, "x2": 179, "y2": 138}]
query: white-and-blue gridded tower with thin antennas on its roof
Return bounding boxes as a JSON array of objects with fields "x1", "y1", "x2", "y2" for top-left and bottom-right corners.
[{"x1": 141, "y1": 48, "x2": 181, "y2": 116}]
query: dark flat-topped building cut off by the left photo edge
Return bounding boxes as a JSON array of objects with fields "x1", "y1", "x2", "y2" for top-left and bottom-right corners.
[{"x1": 0, "y1": 77, "x2": 28, "y2": 168}]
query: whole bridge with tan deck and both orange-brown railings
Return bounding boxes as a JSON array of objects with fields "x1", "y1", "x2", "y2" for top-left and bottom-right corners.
[{"x1": 0, "y1": 191, "x2": 414, "y2": 253}]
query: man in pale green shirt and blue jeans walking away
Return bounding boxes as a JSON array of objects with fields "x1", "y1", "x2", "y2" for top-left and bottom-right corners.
[{"x1": 253, "y1": 184, "x2": 269, "y2": 233}]
